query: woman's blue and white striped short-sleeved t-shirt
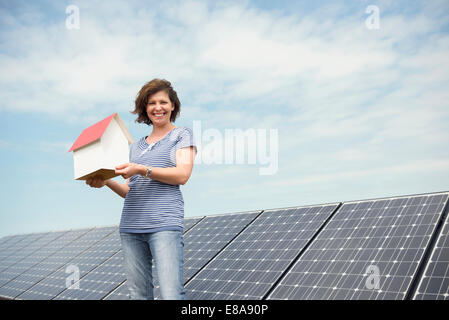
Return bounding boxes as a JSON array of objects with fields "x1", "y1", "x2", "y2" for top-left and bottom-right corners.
[{"x1": 120, "y1": 127, "x2": 197, "y2": 233}]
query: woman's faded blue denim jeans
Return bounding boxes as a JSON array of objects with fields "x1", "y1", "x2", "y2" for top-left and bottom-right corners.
[{"x1": 120, "y1": 231, "x2": 185, "y2": 300}]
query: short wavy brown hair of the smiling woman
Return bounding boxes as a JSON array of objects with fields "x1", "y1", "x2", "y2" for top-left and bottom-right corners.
[{"x1": 131, "y1": 79, "x2": 181, "y2": 125}]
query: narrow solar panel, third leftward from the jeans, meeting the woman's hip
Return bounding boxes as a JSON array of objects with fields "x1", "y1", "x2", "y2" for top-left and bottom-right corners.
[{"x1": 17, "y1": 227, "x2": 120, "y2": 300}]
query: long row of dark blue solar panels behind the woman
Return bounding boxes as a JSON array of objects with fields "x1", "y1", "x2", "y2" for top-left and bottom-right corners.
[{"x1": 0, "y1": 192, "x2": 449, "y2": 300}]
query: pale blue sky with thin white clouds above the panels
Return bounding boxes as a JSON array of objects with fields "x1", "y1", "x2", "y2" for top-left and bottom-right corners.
[{"x1": 0, "y1": 0, "x2": 449, "y2": 237}]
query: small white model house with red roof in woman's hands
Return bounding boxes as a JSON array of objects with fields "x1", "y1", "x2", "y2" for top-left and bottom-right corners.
[{"x1": 69, "y1": 113, "x2": 133, "y2": 180}]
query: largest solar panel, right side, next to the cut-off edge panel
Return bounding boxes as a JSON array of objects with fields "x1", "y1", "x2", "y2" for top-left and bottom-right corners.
[{"x1": 268, "y1": 194, "x2": 448, "y2": 299}]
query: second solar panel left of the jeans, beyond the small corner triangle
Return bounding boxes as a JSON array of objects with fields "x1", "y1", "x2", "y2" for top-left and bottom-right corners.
[{"x1": 54, "y1": 250, "x2": 126, "y2": 300}]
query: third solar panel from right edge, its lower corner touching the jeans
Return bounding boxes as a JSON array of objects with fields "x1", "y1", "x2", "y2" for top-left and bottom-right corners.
[{"x1": 186, "y1": 204, "x2": 338, "y2": 299}]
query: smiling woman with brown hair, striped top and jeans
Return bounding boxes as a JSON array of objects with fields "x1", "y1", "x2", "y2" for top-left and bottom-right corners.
[{"x1": 86, "y1": 79, "x2": 197, "y2": 299}]
